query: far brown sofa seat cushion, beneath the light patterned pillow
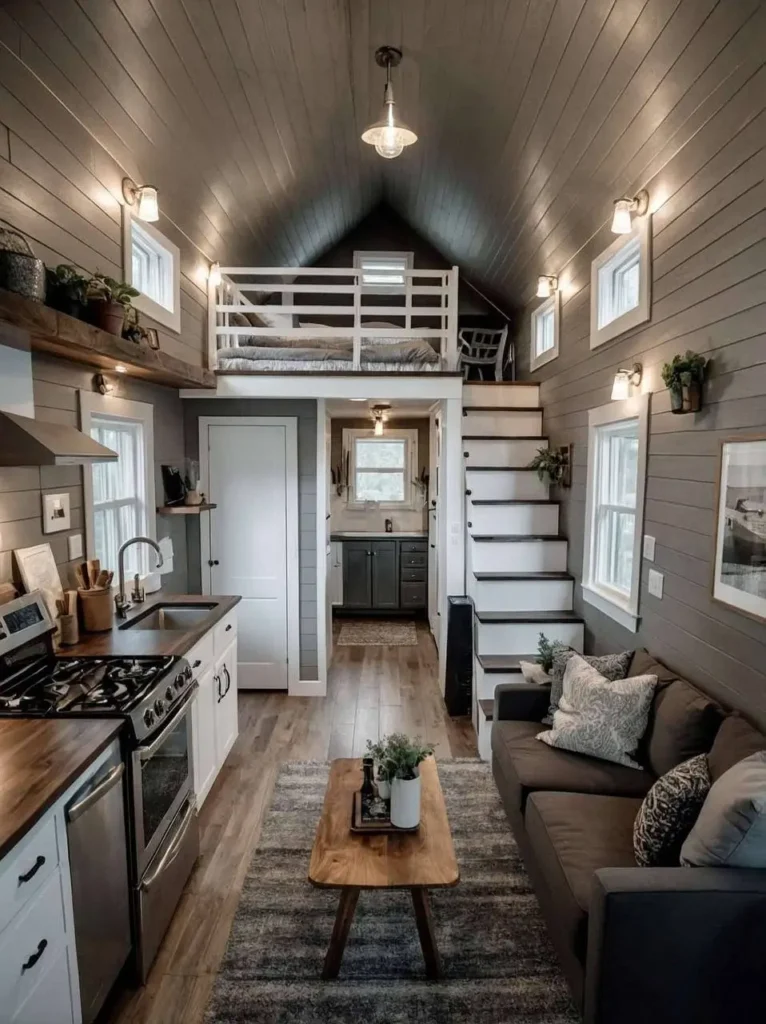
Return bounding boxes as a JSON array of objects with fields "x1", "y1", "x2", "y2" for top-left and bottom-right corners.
[{"x1": 492, "y1": 722, "x2": 654, "y2": 813}]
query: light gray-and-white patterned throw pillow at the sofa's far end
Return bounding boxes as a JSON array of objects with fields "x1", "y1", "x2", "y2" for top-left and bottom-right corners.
[{"x1": 538, "y1": 654, "x2": 657, "y2": 769}]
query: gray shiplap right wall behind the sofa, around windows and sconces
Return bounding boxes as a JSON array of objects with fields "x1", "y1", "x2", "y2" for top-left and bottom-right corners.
[{"x1": 518, "y1": 66, "x2": 766, "y2": 722}]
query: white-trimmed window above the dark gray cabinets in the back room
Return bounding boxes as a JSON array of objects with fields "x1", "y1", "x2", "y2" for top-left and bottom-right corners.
[{"x1": 343, "y1": 429, "x2": 418, "y2": 508}]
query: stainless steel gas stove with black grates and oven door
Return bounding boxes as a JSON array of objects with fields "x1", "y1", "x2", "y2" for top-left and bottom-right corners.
[{"x1": 0, "y1": 593, "x2": 199, "y2": 980}]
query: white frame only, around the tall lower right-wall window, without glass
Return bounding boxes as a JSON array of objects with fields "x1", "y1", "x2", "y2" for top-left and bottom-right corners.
[{"x1": 583, "y1": 394, "x2": 649, "y2": 633}]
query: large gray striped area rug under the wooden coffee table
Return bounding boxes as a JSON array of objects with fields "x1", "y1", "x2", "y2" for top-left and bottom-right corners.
[{"x1": 206, "y1": 760, "x2": 580, "y2": 1024}]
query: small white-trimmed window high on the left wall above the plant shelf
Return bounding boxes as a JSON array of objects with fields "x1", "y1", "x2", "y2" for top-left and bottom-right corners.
[{"x1": 123, "y1": 207, "x2": 181, "y2": 331}]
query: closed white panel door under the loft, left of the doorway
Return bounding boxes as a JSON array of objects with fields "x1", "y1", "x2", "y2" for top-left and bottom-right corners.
[{"x1": 203, "y1": 419, "x2": 298, "y2": 690}]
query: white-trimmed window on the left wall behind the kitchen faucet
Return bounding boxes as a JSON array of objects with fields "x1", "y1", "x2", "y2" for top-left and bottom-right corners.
[{"x1": 80, "y1": 391, "x2": 157, "y2": 575}]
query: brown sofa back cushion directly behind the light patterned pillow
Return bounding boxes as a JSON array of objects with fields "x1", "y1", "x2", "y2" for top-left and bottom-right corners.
[{"x1": 629, "y1": 650, "x2": 724, "y2": 775}]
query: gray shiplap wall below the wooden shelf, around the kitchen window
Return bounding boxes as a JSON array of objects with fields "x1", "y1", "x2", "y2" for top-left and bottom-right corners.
[{"x1": 0, "y1": 353, "x2": 186, "y2": 594}]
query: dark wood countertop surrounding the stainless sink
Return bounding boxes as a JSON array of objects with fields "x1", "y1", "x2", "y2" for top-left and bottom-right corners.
[{"x1": 56, "y1": 591, "x2": 242, "y2": 657}]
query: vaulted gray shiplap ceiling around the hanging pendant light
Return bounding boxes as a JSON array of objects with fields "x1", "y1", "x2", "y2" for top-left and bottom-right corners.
[{"x1": 0, "y1": 0, "x2": 766, "y2": 304}]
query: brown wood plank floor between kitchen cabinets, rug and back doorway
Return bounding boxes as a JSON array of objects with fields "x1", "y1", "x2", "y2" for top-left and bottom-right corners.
[{"x1": 104, "y1": 626, "x2": 476, "y2": 1024}]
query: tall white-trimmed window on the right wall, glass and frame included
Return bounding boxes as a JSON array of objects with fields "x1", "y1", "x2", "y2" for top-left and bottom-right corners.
[{"x1": 583, "y1": 395, "x2": 649, "y2": 632}]
